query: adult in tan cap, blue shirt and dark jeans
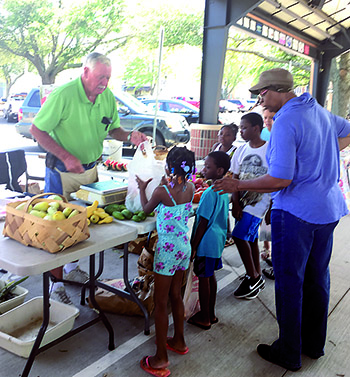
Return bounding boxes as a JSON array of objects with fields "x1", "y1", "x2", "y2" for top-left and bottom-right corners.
[{"x1": 211, "y1": 68, "x2": 350, "y2": 371}]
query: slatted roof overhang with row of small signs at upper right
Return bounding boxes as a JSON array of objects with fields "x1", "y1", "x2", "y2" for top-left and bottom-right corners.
[{"x1": 238, "y1": 0, "x2": 350, "y2": 59}]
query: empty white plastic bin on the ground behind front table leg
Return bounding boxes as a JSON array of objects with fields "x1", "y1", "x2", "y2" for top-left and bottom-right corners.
[{"x1": 0, "y1": 297, "x2": 79, "y2": 358}]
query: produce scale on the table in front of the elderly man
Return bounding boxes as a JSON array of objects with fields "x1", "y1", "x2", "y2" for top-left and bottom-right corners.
[{"x1": 71, "y1": 180, "x2": 128, "y2": 205}]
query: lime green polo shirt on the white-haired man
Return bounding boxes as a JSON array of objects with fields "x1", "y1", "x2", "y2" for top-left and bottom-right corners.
[{"x1": 34, "y1": 77, "x2": 120, "y2": 164}]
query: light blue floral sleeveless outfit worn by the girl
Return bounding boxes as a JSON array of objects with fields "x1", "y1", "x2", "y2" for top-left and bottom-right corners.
[{"x1": 153, "y1": 185, "x2": 192, "y2": 276}]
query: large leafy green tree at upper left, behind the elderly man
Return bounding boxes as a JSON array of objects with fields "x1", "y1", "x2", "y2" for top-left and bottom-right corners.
[{"x1": 0, "y1": 0, "x2": 130, "y2": 84}]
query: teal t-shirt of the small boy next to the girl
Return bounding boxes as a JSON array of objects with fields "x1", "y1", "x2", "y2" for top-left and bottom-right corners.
[{"x1": 192, "y1": 187, "x2": 229, "y2": 258}]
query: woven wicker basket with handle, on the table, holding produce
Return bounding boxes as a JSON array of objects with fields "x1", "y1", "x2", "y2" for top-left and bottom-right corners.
[{"x1": 3, "y1": 193, "x2": 90, "y2": 253}]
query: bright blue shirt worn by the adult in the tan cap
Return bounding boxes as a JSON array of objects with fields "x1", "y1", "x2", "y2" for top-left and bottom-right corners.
[{"x1": 266, "y1": 93, "x2": 350, "y2": 224}]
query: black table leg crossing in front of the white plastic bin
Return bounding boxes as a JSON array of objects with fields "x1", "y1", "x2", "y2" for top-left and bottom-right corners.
[{"x1": 22, "y1": 272, "x2": 50, "y2": 377}]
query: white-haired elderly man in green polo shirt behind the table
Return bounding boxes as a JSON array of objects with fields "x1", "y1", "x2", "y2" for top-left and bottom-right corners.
[{"x1": 30, "y1": 52, "x2": 146, "y2": 304}]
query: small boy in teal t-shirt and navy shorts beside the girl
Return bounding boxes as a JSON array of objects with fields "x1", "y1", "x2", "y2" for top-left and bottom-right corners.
[{"x1": 187, "y1": 151, "x2": 230, "y2": 330}]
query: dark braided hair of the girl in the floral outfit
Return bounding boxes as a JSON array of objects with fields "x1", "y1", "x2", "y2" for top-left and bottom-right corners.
[{"x1": 166, "y1": 147, "x2": 196, "y2": 177}]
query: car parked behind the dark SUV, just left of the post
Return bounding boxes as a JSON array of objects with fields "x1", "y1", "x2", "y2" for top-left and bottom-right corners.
[{"x1": 142, "y1": 98, "x2": 199, "y2": 124}]
